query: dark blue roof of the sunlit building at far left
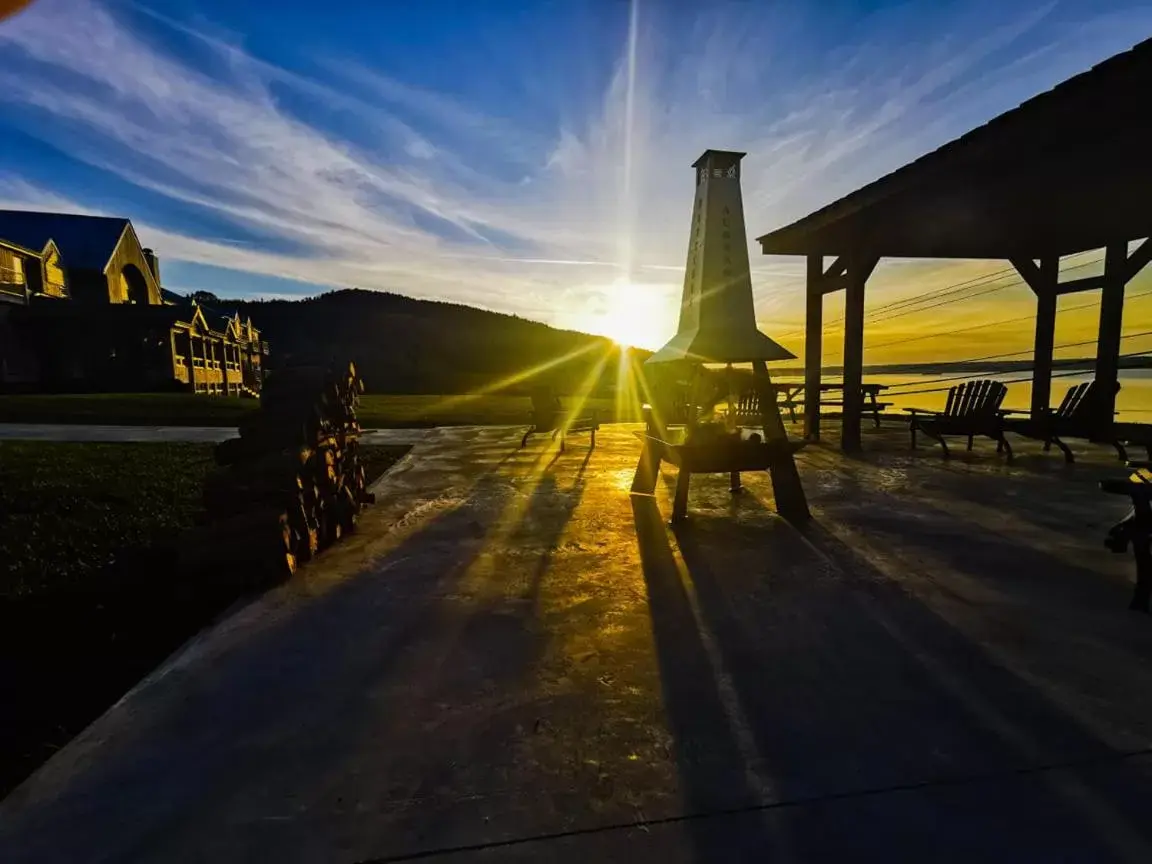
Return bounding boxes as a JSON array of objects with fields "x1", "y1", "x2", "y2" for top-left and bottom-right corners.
[{"x1": 0, "y1": 210, "x2": 129, "y2": 271}]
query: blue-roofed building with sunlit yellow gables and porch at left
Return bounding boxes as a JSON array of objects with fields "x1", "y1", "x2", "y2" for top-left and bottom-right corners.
[{"x1": 0, "y1": 210, "x2": 268, "y2": 395}]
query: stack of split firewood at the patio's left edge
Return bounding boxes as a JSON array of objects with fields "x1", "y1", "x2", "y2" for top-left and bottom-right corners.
[{"x1": 182, "y1": 363, "x2": 374, "y2": 584}]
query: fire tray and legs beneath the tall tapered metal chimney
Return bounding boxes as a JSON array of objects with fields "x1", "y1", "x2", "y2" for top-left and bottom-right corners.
[{"x1": 631, "y1": 427, "x2": 809, "y2": 523}]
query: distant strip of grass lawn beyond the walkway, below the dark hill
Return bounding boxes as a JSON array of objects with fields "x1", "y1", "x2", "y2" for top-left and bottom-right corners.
[{"x1": 0, "y1": 393, "x2": 639, "y2": 429}]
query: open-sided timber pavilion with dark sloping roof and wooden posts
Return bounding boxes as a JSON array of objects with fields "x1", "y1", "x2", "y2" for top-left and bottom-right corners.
[{"x1": 757, "y1": 33, "x2": 1152, "y2": 449}]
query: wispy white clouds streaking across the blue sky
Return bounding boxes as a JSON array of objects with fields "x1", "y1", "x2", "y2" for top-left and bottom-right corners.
[{"x1": 0, "y1": 0, "x2": 1152, "y2": 352}]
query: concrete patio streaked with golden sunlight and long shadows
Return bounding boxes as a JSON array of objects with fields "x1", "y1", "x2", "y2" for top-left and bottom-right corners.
[{"x1": 0, "y1": 426, "x2": 1152, "y2": 864}]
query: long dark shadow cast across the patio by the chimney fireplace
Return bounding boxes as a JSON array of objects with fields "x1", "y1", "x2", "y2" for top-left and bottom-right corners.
[{"x1": 632, "y1": 497, "x2": 1152, "y2": 861}]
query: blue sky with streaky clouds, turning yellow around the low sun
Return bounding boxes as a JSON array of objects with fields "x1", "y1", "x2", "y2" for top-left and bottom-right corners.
[{"x1": 0, "y1": 0, "x2": 1152, "y2": 363}]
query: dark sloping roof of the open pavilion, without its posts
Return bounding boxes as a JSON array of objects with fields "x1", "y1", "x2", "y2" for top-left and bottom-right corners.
[{"x1": 757, "y1": 39, "x2": 1152, "y2": 258}]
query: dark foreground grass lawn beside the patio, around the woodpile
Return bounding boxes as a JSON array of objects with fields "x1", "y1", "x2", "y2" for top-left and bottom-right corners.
[{"x1": 0, "y1": 441, "x2": 408, "y2": 797}]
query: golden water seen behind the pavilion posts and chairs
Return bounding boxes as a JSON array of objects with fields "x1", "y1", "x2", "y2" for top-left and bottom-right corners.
[{"x1": 773, "y1": 369, "x2": 1152, "y2": 423}]
